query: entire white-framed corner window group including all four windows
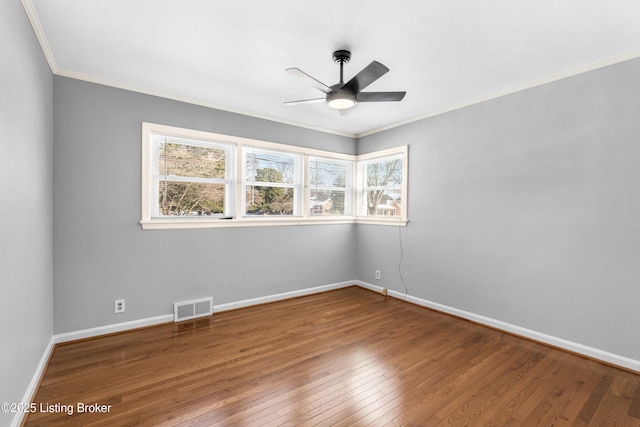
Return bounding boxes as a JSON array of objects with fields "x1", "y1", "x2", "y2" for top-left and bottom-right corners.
[{"x1": 140, "y1": 123, "x2": 407, "y2": 229}]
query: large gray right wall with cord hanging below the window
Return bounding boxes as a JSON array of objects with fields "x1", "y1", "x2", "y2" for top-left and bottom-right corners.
[{"x1": 357, "y1": 59, "x2": 640, "y2": 360}]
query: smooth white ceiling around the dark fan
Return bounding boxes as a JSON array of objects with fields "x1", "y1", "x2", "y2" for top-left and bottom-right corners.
[{"x1": 23, "y1": 0, "x2": 640, "y2": 136}]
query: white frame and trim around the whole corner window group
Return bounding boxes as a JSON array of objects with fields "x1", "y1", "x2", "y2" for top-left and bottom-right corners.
[{"x1": 140, "y1": 123, "x2": 407, "y2": 230}]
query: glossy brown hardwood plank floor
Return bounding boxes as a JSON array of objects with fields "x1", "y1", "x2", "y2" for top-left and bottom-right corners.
[{"x1": 25, "y1": 287, "x2": 640, "y2": 426}]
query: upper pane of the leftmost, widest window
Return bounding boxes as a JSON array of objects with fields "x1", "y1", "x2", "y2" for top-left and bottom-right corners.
[{"x1": 158, "y1": 142, "x2": 226, "y2": 179}]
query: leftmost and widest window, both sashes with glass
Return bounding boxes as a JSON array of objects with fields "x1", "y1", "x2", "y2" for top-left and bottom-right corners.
[{"x1": 151, "y1": 133, "x2": 233, "y2": 218}]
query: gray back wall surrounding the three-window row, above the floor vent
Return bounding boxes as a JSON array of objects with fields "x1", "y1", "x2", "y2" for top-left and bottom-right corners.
[{"x1": 53, "y1": 77, "x2": 356, "y2": 333}]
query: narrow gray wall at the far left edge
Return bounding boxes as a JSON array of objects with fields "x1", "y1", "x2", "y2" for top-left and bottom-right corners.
[{"x1": 0, "y1": 0, "x2": 53, "y2": 425}]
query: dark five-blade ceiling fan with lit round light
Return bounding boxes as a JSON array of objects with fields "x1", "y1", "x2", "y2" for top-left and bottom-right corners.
[{"x1": 285, "y1": 50, "x2": 406, "y2": 110}]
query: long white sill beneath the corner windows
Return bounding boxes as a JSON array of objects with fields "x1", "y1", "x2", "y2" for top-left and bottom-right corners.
[{"x1": 140, "y1": 217, "x2": 408, "y2": 230}]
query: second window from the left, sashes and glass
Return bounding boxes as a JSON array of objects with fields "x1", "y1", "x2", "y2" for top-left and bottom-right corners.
[{"x1": 242, "y1": 147, "x2": 302, "y2": 216}]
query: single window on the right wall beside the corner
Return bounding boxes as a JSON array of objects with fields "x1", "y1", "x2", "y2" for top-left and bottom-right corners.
[{"x1": 358, "y1": 147, "x2": 407, "y2": 221}]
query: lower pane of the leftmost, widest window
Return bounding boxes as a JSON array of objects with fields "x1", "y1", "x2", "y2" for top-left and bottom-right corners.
[{"x1": 158, "y1": 181, "x2": 225, "y2": 216}]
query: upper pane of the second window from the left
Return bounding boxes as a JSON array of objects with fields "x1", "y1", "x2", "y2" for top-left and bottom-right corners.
[{"x1": 245, "y1": 150, "x2": 295, "y2": 184}]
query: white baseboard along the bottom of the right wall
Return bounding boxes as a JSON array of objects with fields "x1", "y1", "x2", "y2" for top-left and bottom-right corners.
[{"x1": 354, "y1": 280, "x2": 640, "y2": 373}]
